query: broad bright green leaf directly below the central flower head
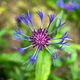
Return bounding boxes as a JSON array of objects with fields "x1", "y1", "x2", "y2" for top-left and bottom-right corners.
[{"x1": 35, "y1": 50, "x2": 51, "y2": 80}]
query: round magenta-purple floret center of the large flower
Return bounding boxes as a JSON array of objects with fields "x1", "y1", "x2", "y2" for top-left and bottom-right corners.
[{"x1": 30, "y1": 28, "x2": 49, "y2": 49}]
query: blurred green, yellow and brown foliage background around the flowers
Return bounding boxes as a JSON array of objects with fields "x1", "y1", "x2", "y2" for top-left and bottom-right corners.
[{"x1": 0, "y1": 0, "x2": 80, "y2": 80}]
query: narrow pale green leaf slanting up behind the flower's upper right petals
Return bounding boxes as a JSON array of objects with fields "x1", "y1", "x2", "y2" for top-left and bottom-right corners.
[{"x1": 48, "y1": 11, "x2": 63, "y2": 36}]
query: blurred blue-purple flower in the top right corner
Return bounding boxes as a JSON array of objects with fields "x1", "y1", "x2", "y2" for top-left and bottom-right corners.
[{"x1": 56, "y1": 0, "x2": 80, "y2": 11}]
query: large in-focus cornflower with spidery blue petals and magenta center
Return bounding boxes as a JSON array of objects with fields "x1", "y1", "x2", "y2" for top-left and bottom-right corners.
[{"x1": 15, "y1": 11, "x2": 69, "y2": 63}]
